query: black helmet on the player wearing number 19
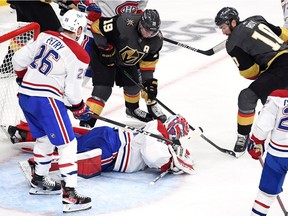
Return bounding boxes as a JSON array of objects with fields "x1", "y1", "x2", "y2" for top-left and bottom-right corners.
[{"x1": 140, "y1": 9, "x2": 161, "y2": 37}]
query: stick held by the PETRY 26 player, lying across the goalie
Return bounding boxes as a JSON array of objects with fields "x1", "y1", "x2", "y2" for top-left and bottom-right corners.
[{"x1": 89, "y1": 113, "x2": 178, "y2": 144}]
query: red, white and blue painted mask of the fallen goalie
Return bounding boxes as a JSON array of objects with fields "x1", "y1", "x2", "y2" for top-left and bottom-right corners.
[{"x1": 164, "y1": 115, "x2": 189, "y2": 140}]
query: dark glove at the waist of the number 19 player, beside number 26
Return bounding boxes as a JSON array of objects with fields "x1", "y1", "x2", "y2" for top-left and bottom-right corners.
[{"x1": 98, "y1": 44, "x2": 116, "y2": 67}]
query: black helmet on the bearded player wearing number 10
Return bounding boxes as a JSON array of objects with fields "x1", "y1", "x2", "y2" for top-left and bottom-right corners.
[{"x1": 215, "y1": 7, "x2": 239, "y2": 27}]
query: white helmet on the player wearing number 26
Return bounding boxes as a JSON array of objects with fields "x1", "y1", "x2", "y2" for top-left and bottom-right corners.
[{"x1": 62, "y1": 9, "x2": 87, "y2": 33}]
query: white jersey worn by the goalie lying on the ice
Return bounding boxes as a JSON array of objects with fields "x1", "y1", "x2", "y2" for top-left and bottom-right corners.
[{"x1": 113, "y1": 120, "x2": 172, "y2": 172}]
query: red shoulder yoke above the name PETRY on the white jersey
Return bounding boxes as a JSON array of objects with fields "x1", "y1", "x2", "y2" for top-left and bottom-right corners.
[{"x1": 44, "y1": 31, "x2": 90, "y2": 64}]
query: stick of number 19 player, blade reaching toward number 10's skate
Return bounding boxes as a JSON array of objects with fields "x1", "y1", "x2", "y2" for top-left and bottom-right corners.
[{"x1": 120, "y1": 68, "x2": 236, "y2": 157}]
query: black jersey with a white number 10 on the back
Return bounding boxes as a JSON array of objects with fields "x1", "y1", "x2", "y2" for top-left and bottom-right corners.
[{"x1": 226, "y1": 16, "x2": 288, "y2": 79}]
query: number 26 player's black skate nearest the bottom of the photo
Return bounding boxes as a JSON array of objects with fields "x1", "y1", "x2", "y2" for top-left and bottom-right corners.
[{"x1": 61, "y1": 181, "x2": 92, "y2": 213}]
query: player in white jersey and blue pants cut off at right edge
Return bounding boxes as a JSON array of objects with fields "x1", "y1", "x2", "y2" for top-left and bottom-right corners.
[{"x1": 248, "y1": 89, "x2": 288, "y2": 215}]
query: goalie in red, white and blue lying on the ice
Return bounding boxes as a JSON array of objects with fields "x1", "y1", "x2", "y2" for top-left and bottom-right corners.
[{"x1": 10, "y1": 115, "x2": 195, "y2": 178}]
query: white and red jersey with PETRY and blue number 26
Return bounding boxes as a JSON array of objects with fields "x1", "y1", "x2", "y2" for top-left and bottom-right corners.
[{"x1": 12, "y1": 31, "x2": 90, "y2": 105}]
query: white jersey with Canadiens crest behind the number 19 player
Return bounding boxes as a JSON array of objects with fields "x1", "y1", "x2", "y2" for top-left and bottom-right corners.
[{"x1": 95, "y1": 0, "x2": 148, "y2": 17}]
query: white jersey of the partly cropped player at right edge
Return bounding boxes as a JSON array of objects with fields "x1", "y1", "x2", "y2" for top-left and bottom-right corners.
[{"x1": 252, "y1": 90, "x2": 288, "y2": 157}]
